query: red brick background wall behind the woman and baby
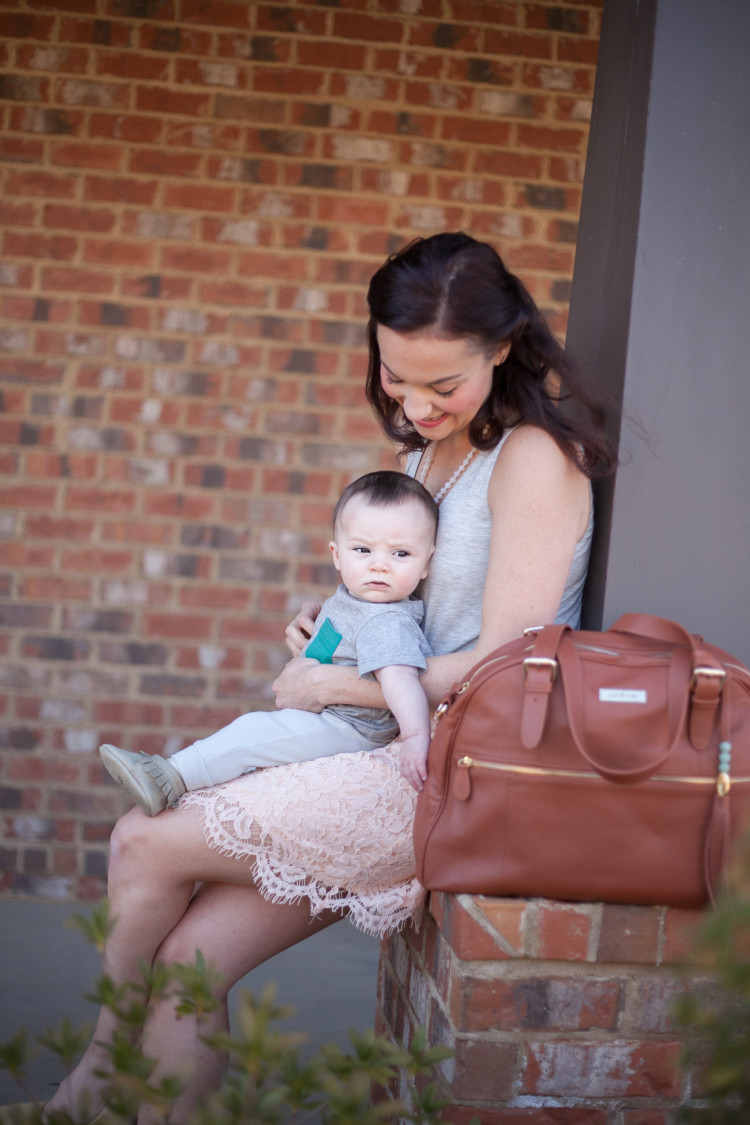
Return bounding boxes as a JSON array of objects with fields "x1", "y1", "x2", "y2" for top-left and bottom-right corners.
[{"x1": 0, "y1": 0, "x2": 600, "y2": 898}]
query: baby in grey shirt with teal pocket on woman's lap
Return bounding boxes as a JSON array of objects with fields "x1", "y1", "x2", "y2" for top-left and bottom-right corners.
[{"x1": 99, "y1": 471, "x2": 437, "y2": 817}]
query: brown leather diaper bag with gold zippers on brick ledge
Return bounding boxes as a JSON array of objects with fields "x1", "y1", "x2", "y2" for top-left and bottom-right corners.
[{"x1": 414, "y1": 613, "x2": 750, "y2": 908}]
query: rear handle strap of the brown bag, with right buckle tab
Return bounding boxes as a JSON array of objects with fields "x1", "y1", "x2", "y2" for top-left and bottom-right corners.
[{"x1": 612, "y1": 613, "x2": 726, "y2": 750}]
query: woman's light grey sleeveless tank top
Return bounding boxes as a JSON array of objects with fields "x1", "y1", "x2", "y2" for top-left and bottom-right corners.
[{"x1": 406, "y1": 430, "x2": 594, "y2": 655}]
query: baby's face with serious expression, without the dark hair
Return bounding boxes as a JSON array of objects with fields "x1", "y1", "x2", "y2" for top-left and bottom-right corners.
[{"x1": 328, "y1": 496, "x2": 435, "y2": 602}]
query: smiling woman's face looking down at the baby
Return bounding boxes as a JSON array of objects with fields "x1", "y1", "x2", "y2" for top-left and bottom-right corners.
[{"x1": 377, "y1": 324, "x2": 509, "y2": 441}]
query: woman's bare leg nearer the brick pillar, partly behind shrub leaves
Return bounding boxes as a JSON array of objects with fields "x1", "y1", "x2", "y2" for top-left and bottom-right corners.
[{"x1": 138, "y1": 883, "x2": 342, "y2": 1125}]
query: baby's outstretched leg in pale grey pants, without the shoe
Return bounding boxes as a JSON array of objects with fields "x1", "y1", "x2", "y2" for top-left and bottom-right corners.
[{"x1": 174, "y1": 708, "x2": 373, "y2": 790}]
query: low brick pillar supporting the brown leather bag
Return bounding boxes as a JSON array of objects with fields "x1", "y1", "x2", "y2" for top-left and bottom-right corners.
[{"x1": 377, "y1": 894, "x2": 707, "y2": 1125}]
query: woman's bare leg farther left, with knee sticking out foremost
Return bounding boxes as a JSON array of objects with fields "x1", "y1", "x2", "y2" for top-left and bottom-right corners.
[{"x1": 48, "y1": 808, "x2": 337, "y2": 1115}]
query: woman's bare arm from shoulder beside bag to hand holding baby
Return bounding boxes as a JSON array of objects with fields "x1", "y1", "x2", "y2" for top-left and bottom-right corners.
[{"x1": 273, "y1": 425, "x2": 590, "y2": 710}]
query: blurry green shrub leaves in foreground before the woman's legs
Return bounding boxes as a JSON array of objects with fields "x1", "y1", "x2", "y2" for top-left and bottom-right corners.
[{"x1": 0, "y1": 903, "x2": 451, "y2": 1125}]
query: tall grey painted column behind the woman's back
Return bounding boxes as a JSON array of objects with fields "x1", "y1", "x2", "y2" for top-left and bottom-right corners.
[{"x1": 568, "y1": 0, "x2": 750, "y2": 663}]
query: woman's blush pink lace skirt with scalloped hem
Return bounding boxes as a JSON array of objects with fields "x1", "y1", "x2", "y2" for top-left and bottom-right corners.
[{"x1": 180, "y1": 744, "x2": 425, "y2": 937}]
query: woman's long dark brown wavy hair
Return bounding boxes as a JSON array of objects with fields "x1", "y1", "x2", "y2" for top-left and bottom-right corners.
[{"x1": 367, "y1": 232, "x2": 614, "y2": 477}]
